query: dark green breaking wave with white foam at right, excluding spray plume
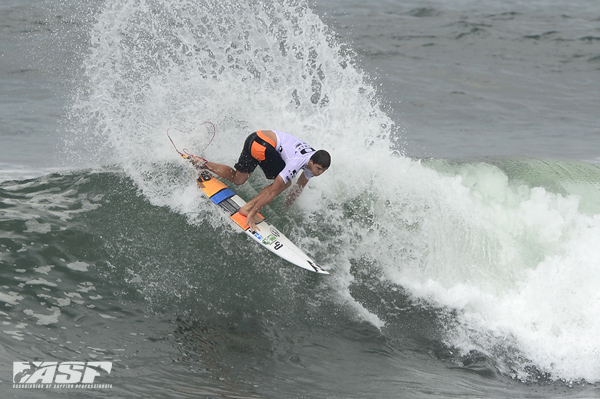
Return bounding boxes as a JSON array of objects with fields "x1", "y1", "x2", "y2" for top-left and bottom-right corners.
[{"x1": 0, "y1": 152, "x2": 600, "y2": 388}]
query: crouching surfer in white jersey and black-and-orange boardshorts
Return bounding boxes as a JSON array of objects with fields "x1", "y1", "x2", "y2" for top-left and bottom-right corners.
[{"x1": 190, "y1": 130, "x2": 331, "y2": 231}]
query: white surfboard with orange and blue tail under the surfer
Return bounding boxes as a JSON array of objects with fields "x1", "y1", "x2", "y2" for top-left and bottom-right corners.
[{"x1": 197, "y1": 170, "x2": 329, "y2": 274}]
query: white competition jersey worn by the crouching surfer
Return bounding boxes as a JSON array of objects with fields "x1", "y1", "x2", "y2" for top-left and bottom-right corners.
[{"x1": 273, "y1": 130, "x2": 315, "y2": 184}]
